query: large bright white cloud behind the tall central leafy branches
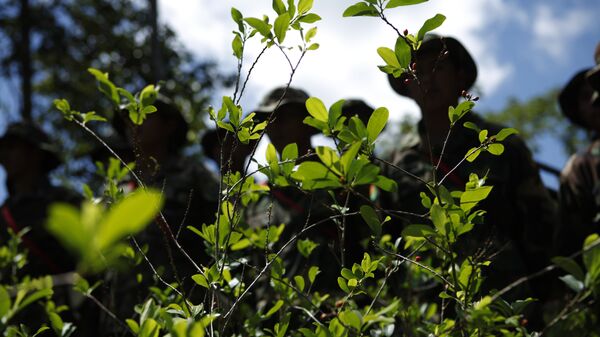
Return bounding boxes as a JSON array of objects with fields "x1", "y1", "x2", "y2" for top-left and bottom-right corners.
[{"x1": 160, "y1": 0, "x2": 522, "y2": 118}]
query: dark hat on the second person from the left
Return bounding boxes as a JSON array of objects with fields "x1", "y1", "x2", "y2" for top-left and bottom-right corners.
[{"x1": 113, "y1": 93, "x2": 189, "y2": 149}]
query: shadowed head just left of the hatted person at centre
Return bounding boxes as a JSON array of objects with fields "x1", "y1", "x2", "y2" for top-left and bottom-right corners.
[{"x1": 202, "y1": 128, "x2": 255, "y2": 173}]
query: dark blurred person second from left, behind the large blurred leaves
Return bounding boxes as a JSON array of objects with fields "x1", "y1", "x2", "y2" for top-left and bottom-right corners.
[{"x1": 103, "y1": 94, "x2": 219, "y2": 331}]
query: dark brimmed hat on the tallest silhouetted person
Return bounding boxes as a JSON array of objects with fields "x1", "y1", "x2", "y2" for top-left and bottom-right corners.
[{"x1": 388, "y1": 34, "x2": 477, "y2": 96}]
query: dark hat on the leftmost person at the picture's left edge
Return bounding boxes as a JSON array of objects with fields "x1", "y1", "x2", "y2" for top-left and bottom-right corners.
[{"x1": 0, "y1": 122, "x2": 61, "y2": 172}]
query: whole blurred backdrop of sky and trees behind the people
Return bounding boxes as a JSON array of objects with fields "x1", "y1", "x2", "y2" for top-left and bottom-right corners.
[{"x1": 0, "y1": 0, "x2": 600, "y2": 202}]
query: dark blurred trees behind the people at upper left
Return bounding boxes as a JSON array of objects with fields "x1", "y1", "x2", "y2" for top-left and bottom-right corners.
[{"x1": 0, "y1": 0, "x2": 228, "y2": 169}]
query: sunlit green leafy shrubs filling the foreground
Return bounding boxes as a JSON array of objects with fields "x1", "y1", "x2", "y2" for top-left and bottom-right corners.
[{"x1": 0, "y1": 0, "x2": 600, "y2": 337}]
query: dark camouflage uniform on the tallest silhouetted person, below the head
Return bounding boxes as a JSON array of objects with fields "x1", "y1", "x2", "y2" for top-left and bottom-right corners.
[{"x1": 383, "y1": 113, "x2": 556, "y2": 288}]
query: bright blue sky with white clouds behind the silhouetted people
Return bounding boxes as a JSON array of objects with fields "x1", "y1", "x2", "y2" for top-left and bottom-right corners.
[{"x1": 0, "y1": 0, "x2": 600, "y2": 200}]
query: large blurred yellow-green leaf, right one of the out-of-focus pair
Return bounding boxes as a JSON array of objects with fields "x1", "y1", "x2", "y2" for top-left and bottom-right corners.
[{"x1": 94, "y1": 190, "x2": 163, "y2": 249}]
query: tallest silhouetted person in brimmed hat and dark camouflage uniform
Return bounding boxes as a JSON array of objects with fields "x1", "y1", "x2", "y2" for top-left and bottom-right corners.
[{"x1": 384, "y1": 35, "x2": 556, "y2": 295}]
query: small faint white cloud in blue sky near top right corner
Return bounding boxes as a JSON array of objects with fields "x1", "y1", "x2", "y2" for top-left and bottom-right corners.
[{"x1": 532, "y1": 5, "x2": 597, "y2": 62}]
